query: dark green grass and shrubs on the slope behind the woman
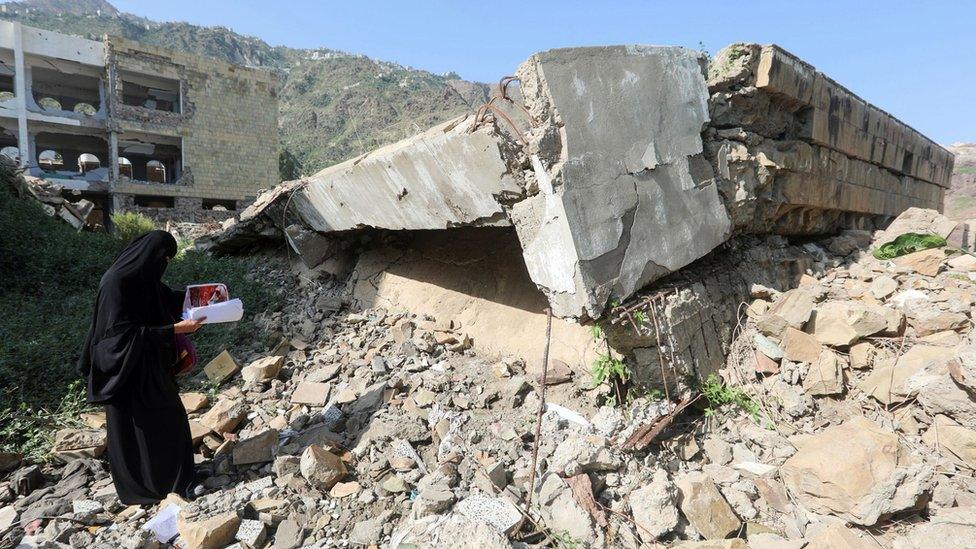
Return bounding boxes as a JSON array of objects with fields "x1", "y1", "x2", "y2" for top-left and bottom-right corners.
[{"x1": 0, "y1": 163, "x2": 280, "y2": 459}]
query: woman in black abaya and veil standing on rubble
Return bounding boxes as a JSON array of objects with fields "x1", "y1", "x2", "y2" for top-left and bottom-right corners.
[{"x1": 78, "y1": 231, "x2": 208, "y2": 505}]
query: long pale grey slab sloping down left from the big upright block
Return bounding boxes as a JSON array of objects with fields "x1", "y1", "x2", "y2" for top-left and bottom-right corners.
[{"x1": 293, "y1": 117, "x2": 522, "y2": 233}]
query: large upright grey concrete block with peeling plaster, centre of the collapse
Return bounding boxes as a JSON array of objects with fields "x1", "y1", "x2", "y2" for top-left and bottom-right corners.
[{"x1": 512, "y1": 46, "x2": 730, "y2": 317}]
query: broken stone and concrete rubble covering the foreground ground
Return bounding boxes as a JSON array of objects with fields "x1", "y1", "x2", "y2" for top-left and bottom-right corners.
[{"x1": 0, "y1": 209, "x2": 976, "y2": 549}]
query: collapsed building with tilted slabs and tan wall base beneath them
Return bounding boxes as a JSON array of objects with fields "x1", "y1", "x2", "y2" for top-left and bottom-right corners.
[{"x1": 214, "y1": 44, "x2": 953, "y2": 384}]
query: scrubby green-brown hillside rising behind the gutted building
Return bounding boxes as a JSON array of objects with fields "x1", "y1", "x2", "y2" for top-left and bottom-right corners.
[{"x1": 0, "y1": 0, "x2": 488, "y2": 179}]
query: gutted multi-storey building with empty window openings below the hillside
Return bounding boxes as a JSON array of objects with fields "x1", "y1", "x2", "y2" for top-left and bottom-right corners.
[{"x1": 0, "y1": 22, "x2": 278, "y2": 226}]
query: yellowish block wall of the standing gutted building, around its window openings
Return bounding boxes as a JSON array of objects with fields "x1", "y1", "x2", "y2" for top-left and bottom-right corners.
[{"x1": 106, "y1": 36, "x2": 278, "y2": 200}]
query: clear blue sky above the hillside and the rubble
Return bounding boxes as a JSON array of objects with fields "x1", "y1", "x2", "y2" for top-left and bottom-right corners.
[{"x1": 112, "y1": 0, "x2": 976, "y2": 144}]
